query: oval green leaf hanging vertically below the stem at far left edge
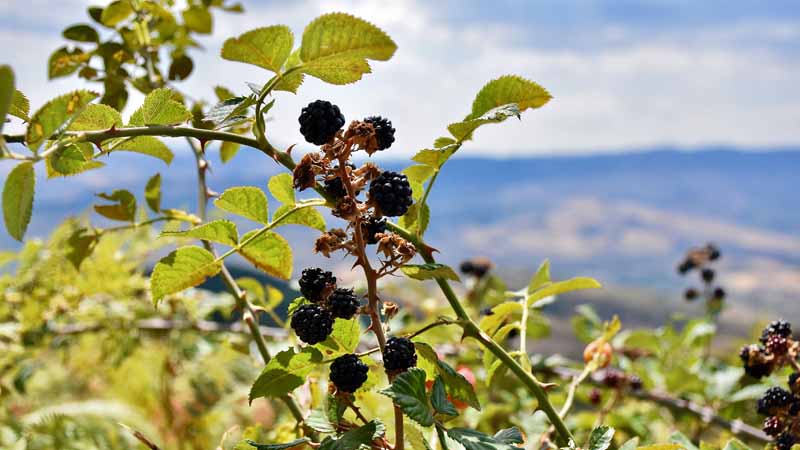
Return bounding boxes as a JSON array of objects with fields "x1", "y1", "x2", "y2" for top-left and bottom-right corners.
[{"x1": 3, "y1": 162, "x2": 36, "y2": 241}]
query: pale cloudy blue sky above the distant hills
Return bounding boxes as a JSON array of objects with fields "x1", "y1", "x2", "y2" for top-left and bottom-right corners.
[{"x1": 0, "y1": 0, "x2": 800, "y2": 157}]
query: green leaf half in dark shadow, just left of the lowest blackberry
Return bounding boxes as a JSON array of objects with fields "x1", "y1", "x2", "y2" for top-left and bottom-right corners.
[{"x1": 249, "y1": 347, "x2": 322, "y2": 403}]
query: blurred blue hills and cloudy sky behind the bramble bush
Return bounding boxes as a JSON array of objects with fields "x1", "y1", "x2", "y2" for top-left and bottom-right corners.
[{"x1": 0, "y1": 0, "x2": 800, "y2": 339}]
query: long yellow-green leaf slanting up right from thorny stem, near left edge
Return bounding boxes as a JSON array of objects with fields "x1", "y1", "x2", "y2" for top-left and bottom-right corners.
[{"x1": 25, "y1": 91, "x2": 97, "y2": 151}]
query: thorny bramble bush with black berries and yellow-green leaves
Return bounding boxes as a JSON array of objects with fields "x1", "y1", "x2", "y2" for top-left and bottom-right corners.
[{"x1": 0, "y1": 0, "x2": 800, "y2": 450}]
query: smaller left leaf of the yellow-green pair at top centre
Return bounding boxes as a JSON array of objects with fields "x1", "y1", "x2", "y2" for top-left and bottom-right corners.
[{"x1": 222, "y1": 25, "x2": 294, "y2": 73}]
